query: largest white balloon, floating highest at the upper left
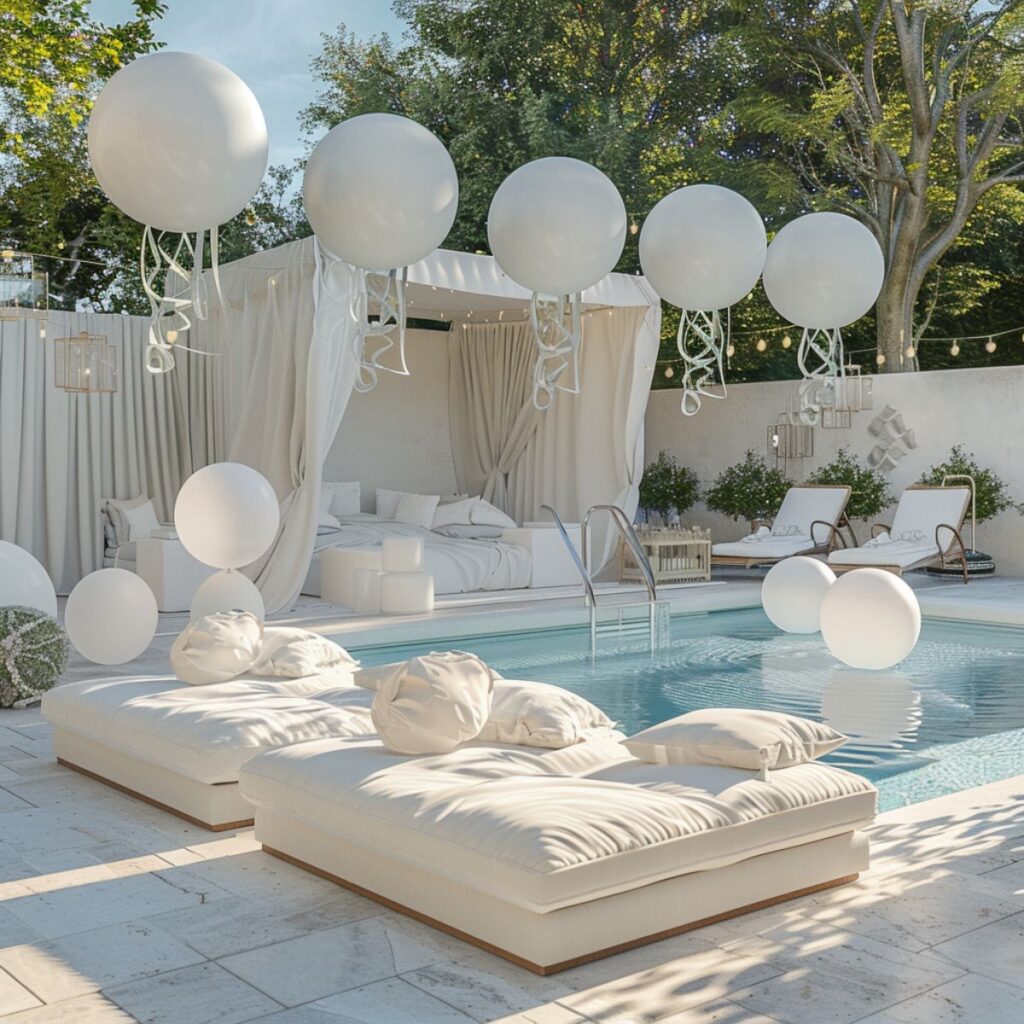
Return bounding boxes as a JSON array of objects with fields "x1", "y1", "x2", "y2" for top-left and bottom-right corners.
[{"x1": 89, "y1": 50, "x2": 267, "y2": 231}]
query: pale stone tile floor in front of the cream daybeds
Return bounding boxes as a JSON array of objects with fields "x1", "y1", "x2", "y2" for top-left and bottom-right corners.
[{"x1": 0, "y1": 710, "x2": 1024, "y2": 1024}]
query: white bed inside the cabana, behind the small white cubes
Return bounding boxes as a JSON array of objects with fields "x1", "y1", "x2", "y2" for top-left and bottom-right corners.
[{"x1": 302, "y1": 513, "x2": 530, "y2": 597}]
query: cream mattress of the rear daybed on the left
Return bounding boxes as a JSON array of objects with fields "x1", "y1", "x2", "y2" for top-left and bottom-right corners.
[{"x1": 42, "y1": 669, "x2": 374, "y2": 784}]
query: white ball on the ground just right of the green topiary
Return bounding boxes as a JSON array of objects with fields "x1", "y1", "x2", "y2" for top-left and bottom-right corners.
[{"x1": 65, "y1": 569, "x2": 158, "y2": 665}]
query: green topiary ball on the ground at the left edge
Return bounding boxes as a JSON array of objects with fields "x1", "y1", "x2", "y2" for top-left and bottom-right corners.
[{"x1": 0, "y1": 604, "x2": 71, "y2": 708}]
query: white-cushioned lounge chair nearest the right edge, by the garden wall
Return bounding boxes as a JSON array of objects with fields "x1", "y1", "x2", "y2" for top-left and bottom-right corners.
[{"x1": 828, "y1": 484, "x2": 971, "y2": 583}]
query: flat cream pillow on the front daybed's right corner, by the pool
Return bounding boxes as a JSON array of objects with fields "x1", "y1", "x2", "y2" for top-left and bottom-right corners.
[{"x1": 623, "y1": 708, "x2": 847, "y2": 771}]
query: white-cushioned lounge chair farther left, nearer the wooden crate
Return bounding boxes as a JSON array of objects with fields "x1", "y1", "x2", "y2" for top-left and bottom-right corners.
[{"x1": 711, "y1": 483, "x2": 857, "y2": 568}]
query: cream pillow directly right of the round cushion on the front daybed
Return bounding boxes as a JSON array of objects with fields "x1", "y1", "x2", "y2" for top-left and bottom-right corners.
[{"x1": 476, "y1": 679, "x2": 615, "y2": 751}]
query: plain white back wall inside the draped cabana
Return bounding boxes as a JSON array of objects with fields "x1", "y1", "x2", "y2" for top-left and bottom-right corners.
[{"x1": 324, "y1": 330, "x2": 456, "y2": 512}]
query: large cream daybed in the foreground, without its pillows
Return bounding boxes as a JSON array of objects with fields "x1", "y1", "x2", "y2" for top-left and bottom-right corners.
[{"x1": 240, "y1": 737, "x2": 876, "y2": 974}]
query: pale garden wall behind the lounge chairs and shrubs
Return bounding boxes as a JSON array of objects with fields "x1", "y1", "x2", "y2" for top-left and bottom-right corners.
[{"x1": 646, "y1": 367, "x2": 1024, "y2": 575}]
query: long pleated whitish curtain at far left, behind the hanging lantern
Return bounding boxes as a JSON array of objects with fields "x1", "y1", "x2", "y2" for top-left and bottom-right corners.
[{"x1": 0, "y1": 311, "x2": 191, "y2": 594}]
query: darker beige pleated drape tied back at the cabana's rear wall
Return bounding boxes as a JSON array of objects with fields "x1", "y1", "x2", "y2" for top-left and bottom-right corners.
[{"x1": 449, "y1": 324, "x2": 543, "y2": 517}]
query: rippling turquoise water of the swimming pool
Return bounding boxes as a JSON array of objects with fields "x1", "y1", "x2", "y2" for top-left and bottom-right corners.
[{"x1": 350, "y1": 609, "x2": 1024, "y2": 810}]
